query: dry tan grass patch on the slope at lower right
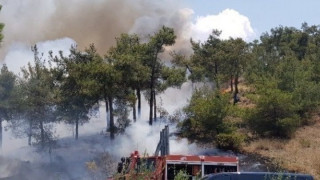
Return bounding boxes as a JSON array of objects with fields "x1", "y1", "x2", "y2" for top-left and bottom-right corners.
[{"x1": 244, "y1": 119, "x2": 320, "y2": 180}]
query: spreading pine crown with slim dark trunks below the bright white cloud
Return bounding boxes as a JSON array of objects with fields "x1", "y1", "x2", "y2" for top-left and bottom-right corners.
[{"x1": 172, "y1": 30, "x2": 253, "y2": 96}]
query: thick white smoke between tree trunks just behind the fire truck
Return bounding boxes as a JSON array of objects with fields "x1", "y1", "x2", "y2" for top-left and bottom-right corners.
[{"x1": 108, "y1": 82, "x2": 199, "y2": 156}]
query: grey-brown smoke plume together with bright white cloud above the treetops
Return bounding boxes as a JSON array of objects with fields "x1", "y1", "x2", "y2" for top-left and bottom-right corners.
[{"x1": 0, "y1": 0, "x2": 255, "y2": 69}]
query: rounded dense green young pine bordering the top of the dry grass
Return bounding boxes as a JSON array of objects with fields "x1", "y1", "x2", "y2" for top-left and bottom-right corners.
[{"x1": 248, "y1": 88, "x2": 300, "y2": 137}]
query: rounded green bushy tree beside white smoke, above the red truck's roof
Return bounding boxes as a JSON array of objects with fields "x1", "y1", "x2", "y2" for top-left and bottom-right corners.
[{"x1": 179, "y1": 89, "x2": 230, "y2": 141}]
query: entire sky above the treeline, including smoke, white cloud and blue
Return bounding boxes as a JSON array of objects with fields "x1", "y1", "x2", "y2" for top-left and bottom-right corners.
[{"x1": 0, "y1": 0, "x2": 320, "y2": 73}]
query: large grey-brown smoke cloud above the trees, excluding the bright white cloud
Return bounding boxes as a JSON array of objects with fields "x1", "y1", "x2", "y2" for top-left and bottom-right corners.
[{"x1": 0, "y1": 0, "x2": 188, "y2": 60}]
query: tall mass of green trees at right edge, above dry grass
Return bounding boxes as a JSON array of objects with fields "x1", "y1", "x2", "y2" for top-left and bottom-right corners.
[{"x1": 246, "y1": 23, "x2": 320, "y2": 137}]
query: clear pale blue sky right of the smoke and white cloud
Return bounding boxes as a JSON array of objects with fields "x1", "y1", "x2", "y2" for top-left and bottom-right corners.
[{"x1": 185, "y1": 0, "x2": 320, "y2": 35}]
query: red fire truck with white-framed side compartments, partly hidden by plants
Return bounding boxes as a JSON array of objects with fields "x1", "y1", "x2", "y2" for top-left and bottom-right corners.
[{"x1": 114, "y1": 151, "x2": 239, "y2": 180}]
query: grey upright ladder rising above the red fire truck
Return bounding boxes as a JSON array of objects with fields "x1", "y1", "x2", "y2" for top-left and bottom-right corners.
[{"x1": 154, "y1": 125, "x2": 170, "y2": 156}]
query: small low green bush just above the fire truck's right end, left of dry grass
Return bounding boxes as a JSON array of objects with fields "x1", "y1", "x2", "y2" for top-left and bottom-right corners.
[{"x1": 216, "y1": 132, "x2": 245, "y2": 151}]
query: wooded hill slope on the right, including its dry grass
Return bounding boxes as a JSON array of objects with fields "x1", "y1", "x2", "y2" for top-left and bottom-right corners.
[{"x1": 176, "y1": 23, "x2": 320, "y2": 177}]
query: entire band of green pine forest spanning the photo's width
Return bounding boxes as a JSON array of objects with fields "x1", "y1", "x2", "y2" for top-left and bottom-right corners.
[{"x1": 0, "y1": 23, "x2": 320, "y2": 154}]
